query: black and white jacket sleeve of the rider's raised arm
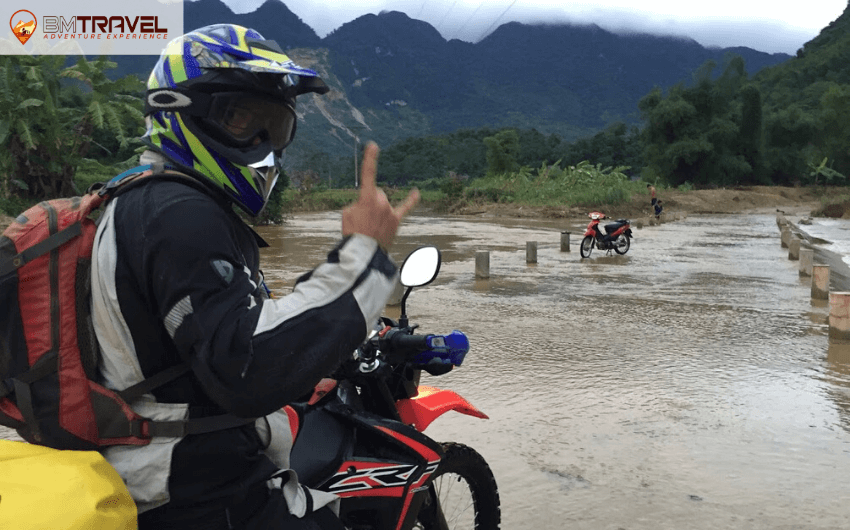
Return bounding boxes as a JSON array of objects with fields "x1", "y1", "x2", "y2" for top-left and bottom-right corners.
[{"x1": 143, "y1": 194, "x2": 397, "y2": 417}]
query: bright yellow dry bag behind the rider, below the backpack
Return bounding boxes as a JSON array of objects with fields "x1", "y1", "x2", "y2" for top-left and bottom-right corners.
[{"x1": 0, "y1": 440, "x2": 138, "y2": 530}]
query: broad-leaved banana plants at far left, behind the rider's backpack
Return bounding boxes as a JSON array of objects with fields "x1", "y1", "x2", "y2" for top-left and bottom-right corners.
[{"x1": 0, "y1": 55, "x2": 143, "y2": 201}]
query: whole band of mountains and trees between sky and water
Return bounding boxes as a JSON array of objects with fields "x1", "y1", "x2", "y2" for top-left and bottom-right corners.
[{"x1": 0, "y1": 0, "x2": 850, "y2": 219}]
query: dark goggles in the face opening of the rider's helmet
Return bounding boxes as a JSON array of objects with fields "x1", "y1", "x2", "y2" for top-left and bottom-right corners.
[{"x1": 204, "y1": 92, "x2": 296, "y2": 150}]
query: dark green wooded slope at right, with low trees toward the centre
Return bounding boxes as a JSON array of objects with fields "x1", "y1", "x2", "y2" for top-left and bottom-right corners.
[{"x1": 372, "y1": 1, "x2": 850, "y2": 192}]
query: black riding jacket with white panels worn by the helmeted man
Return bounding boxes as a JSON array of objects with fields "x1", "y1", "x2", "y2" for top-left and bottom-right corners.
[{"x1": 92, "y1": 166, "x2": 396, "y2": 513}]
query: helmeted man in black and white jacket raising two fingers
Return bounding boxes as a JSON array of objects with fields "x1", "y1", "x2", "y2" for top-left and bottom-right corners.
[{"x1": 92, "y1": 24, "x2": 418, "y2": 530}]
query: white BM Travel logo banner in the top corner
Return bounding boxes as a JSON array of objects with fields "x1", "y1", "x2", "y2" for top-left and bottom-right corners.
[{"x1": 0, "y1": 0, "x2": 183, "y2": 55}]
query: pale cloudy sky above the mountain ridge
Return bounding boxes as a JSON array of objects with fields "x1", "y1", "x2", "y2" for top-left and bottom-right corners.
[{"x1": 217, "y1": 0, "x2": 847, "y2": 54}]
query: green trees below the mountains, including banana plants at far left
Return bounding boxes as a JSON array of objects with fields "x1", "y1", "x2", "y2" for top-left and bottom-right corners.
[{"x1": 0, "y1": 48, "x2": 850, "y2": 217}]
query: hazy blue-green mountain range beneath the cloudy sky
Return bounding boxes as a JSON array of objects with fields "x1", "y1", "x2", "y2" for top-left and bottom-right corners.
[{"x1": 109, "y1": 0, "x2": 790, "y2": 166}]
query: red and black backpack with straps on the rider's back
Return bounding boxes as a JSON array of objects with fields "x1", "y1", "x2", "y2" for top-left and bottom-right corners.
[{"x1": 0, "y1": 166, "x2": 253, "y2": 450}]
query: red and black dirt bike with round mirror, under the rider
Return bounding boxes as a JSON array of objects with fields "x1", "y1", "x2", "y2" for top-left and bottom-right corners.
[{"x1": 290, "y1": 247, "x2": 501, "y2": 530}]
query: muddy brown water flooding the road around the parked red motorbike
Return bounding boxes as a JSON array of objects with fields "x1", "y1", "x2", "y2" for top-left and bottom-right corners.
[{"x1": 1, "y1": 213, "x2": 850, "y2": 530}]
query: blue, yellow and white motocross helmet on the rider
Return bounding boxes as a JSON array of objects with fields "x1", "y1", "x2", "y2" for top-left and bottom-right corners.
[{"x1": 142, "y1": 24, "x2": 329, "y2": 216}]
